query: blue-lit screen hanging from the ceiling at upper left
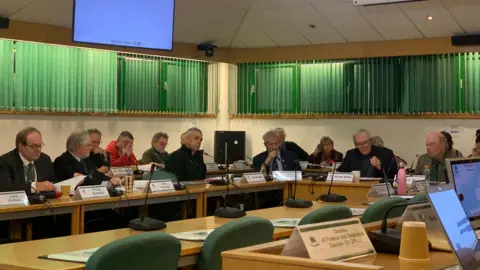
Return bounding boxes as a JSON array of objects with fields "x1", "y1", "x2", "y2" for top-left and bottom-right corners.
[{"x1": 73, "y1": 0, "x2": 175, "y2": 50}]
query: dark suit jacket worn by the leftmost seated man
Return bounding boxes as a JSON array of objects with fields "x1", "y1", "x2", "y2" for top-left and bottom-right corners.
[{"x1": 0, "y1": 149, "x2": 55, "y2": 193}]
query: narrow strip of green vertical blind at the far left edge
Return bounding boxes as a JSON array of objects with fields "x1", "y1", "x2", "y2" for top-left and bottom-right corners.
[{"x1": 0, "y1": 40, "x2": 14, "y2": 110}]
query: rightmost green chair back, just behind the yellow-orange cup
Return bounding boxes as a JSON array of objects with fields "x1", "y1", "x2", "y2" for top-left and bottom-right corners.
[{"x1": 361, "y1": 197, "x2": 407, "y2": 224}]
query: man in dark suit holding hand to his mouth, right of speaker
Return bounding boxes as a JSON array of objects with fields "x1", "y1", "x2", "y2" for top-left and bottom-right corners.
[{"x1": 253, "y1": 131, "x2": 298, "y2": 175}]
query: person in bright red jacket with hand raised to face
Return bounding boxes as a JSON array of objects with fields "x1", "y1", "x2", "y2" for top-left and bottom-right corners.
[{"x1": 105, "y1": 131, "x2": 139, "y2": 167}]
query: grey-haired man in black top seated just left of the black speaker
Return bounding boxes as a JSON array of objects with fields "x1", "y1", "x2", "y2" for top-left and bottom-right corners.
[{"x1": 165, "y1": 128, "x2": 207, "y2": 181}]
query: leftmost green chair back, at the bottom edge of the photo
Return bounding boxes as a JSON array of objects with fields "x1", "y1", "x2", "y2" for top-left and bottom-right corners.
[{"x1": 85, "y1": 232, "x2": 181, "y2": 270}]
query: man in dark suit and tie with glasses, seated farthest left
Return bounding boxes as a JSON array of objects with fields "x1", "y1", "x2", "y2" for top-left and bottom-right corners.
[{"x1": 0, "y1": 127, "x2": 55, "y2": 193}]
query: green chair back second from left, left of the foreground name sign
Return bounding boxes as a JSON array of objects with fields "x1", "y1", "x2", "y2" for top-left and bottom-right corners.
[{"x1": 198, "y1": 217, "x2": 273, "y2": 270}]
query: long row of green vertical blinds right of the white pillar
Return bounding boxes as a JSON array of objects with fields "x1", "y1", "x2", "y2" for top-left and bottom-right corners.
[{"x1": 237, "y1": 53, "x2": 480, "y2": 115}]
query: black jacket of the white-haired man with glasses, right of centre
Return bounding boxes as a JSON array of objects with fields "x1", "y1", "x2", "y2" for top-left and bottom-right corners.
[{"x1": 337, "y1": 145, "x2": 398, "y2": 178}]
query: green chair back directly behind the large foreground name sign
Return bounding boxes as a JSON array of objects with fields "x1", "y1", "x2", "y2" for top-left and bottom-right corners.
[{"x1": 298, "y1": 205, "x2": 352, "y2": 225}]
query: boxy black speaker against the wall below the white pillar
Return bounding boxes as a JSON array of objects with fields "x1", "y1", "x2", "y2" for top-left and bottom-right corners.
[{"x1": 213, "y1": 131, "x2": 245, "y2": 164}]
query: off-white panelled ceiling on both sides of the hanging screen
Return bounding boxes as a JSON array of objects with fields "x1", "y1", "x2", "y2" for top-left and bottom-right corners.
[{"x1": 0, "y1": 0, "x2": 480, "y2": 48}]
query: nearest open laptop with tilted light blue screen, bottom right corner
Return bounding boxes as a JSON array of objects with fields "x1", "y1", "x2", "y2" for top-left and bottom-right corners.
[{"x1": 427, "y1": 184, "x2": 480, "y2": 270}]
